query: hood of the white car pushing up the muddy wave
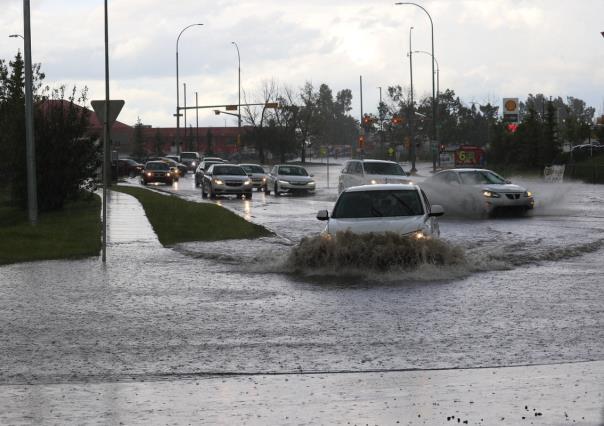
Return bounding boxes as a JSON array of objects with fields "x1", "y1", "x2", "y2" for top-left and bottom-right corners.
[{"x1": 326, "y1": 216, "x2": 425, "y2": 235}]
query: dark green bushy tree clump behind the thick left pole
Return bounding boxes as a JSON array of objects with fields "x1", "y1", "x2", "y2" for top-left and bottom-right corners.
[{"x1": 0, "y1": 54, "x2": 100, "y2": 211}]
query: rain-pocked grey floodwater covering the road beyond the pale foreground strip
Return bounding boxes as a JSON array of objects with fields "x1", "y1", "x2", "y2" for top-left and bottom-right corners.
[{"x1": 0, "y1": 160, "x2": 604, "y2": 424}]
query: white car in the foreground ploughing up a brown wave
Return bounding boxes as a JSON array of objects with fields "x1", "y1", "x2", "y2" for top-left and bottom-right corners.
[{"x1": 317, "y1": 184, "x2": 444, "y2": 238}]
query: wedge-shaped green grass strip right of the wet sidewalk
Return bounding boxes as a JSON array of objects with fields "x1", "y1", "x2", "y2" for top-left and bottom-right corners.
[{"x1": 112, "y1": 186, "x2": 272, "y2": 246}]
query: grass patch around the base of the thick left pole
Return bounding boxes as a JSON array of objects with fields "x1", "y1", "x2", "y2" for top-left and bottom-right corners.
[{"x1": 0, "y1": 195, "x2": 101, "y2": 265}]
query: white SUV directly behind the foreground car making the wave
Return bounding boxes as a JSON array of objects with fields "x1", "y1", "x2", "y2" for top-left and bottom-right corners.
[{"x1": 338, "y1": 160, "x2": 413, "y2": 192}]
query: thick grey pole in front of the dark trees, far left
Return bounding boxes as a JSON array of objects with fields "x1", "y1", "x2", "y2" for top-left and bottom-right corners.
[{"x1": 23, "y1": 0, "x2": 38, "y2": 225}]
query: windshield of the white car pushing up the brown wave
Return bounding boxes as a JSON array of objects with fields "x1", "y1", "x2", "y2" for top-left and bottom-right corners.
[{"x1": 332, "y1": 189, "x2": 424, "y2": 219}]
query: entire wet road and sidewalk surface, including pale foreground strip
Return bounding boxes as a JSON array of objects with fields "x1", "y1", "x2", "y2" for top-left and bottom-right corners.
[{"x1": 0, "y1": 162, "x2": 604, "y2": 425}]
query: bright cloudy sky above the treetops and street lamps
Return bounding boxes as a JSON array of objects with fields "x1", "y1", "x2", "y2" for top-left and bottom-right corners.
[{"x1": 0, "y1": 0, "x2": 604, "y2": 127}]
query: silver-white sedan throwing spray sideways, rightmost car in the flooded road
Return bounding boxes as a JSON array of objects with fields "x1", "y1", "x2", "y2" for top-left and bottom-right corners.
[{"x1": 421, "y1": 168, "x2": 535, "y2": 215}]
